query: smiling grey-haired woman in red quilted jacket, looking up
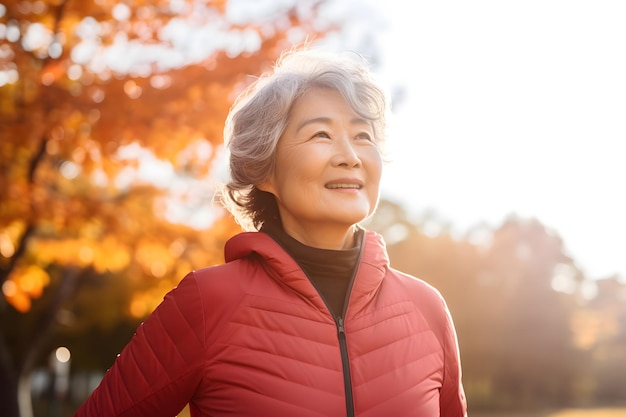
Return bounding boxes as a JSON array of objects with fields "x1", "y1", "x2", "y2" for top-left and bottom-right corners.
[{"x1": 76, "y1": 46, "x2": 466, "y2": 417}]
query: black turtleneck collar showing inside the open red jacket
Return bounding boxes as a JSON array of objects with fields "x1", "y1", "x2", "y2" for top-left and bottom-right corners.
[{"x1": 261, "y1": 224, "x2": 363, "y2": 316}]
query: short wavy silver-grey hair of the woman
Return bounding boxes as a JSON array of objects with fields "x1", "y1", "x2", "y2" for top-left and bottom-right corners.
[{"x1": 217, "y1": 48, "x2": 389, "y2": 230}]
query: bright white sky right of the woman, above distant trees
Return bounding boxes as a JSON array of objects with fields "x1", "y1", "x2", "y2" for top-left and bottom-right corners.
[{"x1": 370, "y1": 0, "x2": 626, "y2": 278}]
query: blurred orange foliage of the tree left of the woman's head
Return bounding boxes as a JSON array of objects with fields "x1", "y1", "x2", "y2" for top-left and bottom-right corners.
[{"x1": 0, "y1": 0, "x2": 330, "y2": 317}]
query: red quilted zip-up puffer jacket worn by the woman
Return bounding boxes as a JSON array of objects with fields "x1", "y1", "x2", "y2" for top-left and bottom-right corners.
[{"x1": 75, "y1": 231, "x2": 466, "y2": 417}]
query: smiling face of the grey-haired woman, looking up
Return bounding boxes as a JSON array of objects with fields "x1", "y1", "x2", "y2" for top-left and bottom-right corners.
[{"x1": 259, "y1": 88, "x2": 382, "y2": 248}]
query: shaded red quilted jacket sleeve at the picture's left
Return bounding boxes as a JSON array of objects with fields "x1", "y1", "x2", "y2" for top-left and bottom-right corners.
[{"x1": 74, "y1": 274, "x2": 205, "y2": 417}]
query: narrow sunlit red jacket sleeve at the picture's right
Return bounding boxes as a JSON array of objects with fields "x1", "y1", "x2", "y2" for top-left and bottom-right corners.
[{"x1": 439, "y1": 301, "x2": 467, "y2": 417}]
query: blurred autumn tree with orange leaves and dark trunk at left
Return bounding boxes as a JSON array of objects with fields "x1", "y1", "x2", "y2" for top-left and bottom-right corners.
[{"x1": 0, "y1": 0, "x2": 352, "y2": 417}]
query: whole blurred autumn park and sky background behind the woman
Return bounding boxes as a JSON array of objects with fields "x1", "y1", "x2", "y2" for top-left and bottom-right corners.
[{"x1": 0, "y1": 0, "x2": 626, "y2": 417}]
